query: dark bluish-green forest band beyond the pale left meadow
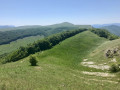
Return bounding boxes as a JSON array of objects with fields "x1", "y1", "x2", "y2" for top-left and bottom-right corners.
[{"x1": 0, "y1": 27, "x2": 78, "y2": 45}]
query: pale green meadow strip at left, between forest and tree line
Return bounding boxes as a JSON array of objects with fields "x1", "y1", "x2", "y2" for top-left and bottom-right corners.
[{"x1": 0, "y1": 35, "x2": 44, "y2": 55}]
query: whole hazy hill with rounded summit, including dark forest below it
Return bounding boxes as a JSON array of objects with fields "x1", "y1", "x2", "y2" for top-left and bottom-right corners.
[{"x1": 0, "y1": 22, "x2": 91, "y2": 45}]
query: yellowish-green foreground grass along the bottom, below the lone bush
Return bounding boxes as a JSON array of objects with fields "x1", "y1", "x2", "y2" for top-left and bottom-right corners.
[{"x1": 0, "y1": 59, "x2": 120, "y2": 90}]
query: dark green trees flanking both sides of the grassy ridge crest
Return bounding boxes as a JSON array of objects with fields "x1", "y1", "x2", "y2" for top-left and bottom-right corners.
[{"x1": 1, "y1": 29, "x2": 118, "y2": 63}]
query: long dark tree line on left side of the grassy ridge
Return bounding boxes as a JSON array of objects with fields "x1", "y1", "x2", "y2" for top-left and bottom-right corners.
[{"x1": 3, "y1": 29, "x2": 87, "y2": 63}]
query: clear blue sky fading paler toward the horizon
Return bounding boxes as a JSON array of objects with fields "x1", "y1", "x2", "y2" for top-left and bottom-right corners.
[{"x1": 0, "y1": 0, "x2": 120, "y2": 26}]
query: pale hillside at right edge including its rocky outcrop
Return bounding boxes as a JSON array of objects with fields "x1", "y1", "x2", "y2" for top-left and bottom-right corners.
[{"x1": 88, "y1": 36, "x2": 120, "y2": 66}]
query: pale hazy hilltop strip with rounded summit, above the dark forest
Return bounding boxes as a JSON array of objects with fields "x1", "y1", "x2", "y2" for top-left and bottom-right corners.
[{"x1": 0, "y1": 22, "x2": 91, "y2": 31}]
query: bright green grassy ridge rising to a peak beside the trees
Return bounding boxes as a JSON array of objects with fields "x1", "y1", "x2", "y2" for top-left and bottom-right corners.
[{"x1": 37, "y1": 31, "x2": 107, "y2": 69}]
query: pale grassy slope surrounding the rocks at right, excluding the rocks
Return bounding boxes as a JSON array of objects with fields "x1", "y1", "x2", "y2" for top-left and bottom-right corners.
[{"x1": 88, "y1": 39, "x2": 120, "y2": 65}]
